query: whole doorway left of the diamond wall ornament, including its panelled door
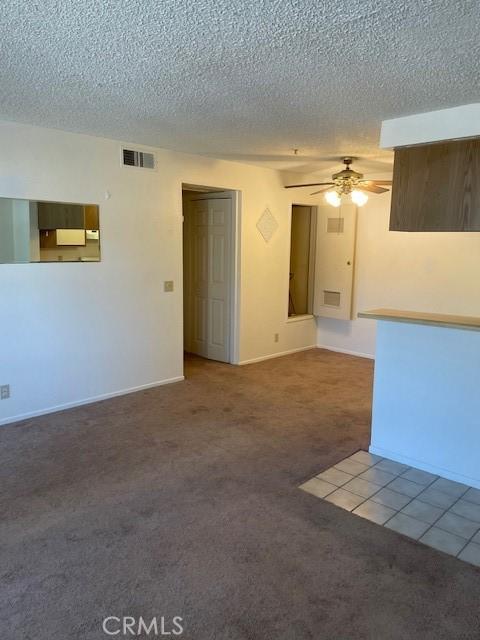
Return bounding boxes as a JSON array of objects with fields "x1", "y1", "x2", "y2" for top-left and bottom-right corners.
[{"x1": 182, "y1": 185, "x2": 239, "y2": 363}]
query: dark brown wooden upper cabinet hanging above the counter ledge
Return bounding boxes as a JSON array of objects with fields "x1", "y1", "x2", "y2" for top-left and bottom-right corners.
[{"x1": 390, "y1": 138, "x2": 480, "y2": 231}]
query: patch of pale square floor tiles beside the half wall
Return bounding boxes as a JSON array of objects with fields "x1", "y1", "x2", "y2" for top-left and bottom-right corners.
[{"x1": 300, "y1": 451, "x2": 480, "y2": 567}]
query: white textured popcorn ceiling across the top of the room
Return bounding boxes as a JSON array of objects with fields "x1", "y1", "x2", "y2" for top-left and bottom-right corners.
[{"x1": 0, "y1": 0, "x2": 480, "y2": 173}]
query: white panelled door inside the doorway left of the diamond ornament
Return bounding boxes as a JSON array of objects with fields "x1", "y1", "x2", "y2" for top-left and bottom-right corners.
[{"x1": 185, "y1": 198, "x2": 232, "y2": 362}]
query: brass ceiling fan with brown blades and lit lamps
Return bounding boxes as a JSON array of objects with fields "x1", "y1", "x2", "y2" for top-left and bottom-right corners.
[{"x1": 285, "y1": 157, "x2": 392, "y2": 207}]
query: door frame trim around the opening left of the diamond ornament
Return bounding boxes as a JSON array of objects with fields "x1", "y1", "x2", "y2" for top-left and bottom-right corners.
[{"x1": 180, "y1": 182, "x2": 241, "y2": 364}]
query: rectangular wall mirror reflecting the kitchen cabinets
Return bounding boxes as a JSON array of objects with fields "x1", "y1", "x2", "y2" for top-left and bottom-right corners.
[{"x1": 0, "y1": 198, "x2": 100, "y2": 263}]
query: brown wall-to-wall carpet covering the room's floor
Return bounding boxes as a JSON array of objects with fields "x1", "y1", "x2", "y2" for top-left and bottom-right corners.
[{"x1": 0, "y1": 349, "x2": 480, "y2": 640}]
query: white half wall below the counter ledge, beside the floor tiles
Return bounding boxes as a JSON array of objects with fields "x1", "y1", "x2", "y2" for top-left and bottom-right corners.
[{"x1": 369, "y1": 321, "x2": 480, "y2": 488}]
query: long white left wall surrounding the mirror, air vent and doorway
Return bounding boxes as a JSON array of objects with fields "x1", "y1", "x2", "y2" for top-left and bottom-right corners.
[{"x1": 0, "y1": 123, "x2": 316, "y2": 423}]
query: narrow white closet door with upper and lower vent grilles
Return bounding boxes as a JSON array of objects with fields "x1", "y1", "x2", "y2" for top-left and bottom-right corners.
[{"x1": 313, "y1": 204, "x2": 357, "y2": 320}]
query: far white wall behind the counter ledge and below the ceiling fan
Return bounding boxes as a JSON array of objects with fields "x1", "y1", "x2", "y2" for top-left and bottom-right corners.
[{"x1": 317, "y1": 193, "x2": 480, "y2": 355}]
